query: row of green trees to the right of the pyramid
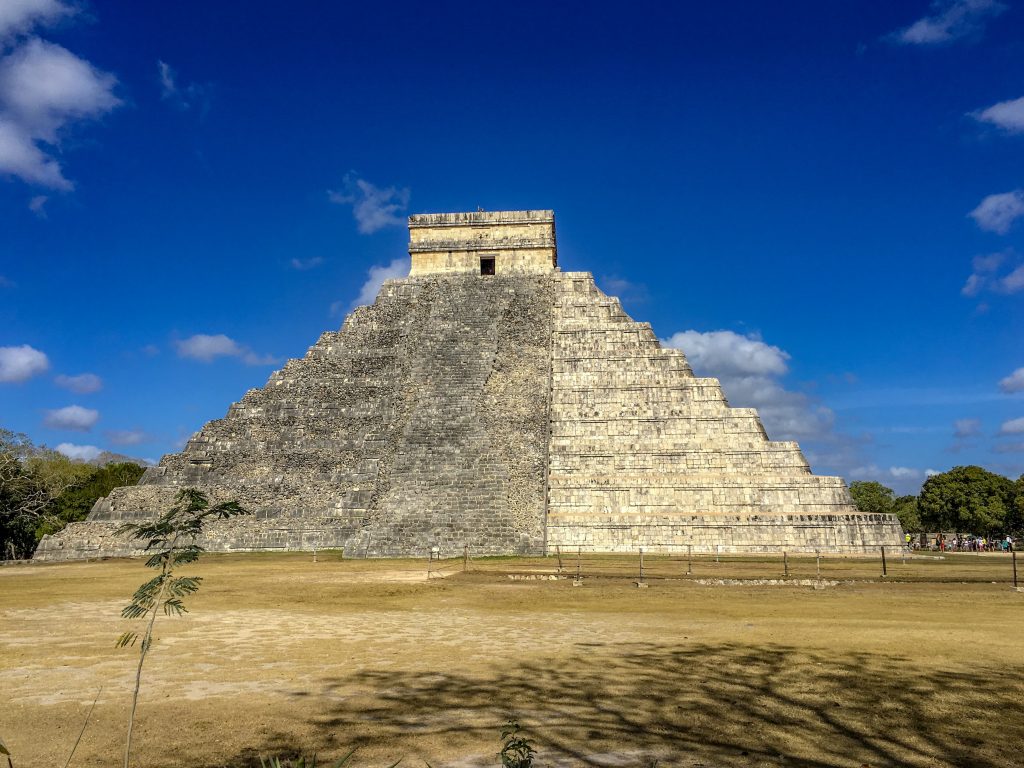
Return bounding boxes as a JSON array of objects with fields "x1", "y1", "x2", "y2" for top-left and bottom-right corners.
[{"x1": 850, "y1": 466, "x2": 1024, "y2": 537}]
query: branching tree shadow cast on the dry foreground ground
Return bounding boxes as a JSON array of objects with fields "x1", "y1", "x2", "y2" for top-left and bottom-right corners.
[{"x1": 220, "y1": 643, "x2": 1024, "y2": 768}]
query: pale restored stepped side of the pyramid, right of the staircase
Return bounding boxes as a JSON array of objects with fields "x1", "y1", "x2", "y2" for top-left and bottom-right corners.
[{"x1": 548, "y1": 272, "x2": 902, "y2": 552}]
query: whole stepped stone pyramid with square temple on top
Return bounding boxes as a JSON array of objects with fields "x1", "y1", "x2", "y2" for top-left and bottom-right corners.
[{"x1": 36, "y1": 211, "x2": 902, "y2": 559}]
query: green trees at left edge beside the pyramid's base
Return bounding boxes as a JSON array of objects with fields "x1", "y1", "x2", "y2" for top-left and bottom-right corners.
[{"x1": 0, "y1": 429, "x2": 145, "y2": 560}]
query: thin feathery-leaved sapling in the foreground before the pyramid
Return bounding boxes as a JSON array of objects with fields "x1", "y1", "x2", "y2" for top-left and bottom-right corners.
[{"x1": 117, "y1": 488, "x2": 250, "y2": 768}]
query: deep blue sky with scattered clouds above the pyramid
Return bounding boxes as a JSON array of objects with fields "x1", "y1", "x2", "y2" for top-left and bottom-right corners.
[{"x1": 0, "y1": 0, "x2": 1024, "y2": 493}]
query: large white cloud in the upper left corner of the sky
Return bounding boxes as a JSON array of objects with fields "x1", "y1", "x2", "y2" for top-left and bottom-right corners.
[{"x1": 0, "y1": 38, "x2": 121, "y2": 190}]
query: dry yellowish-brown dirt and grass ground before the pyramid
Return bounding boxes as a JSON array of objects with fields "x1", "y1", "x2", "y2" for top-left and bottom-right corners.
[{"x1": 0, "y1": 554, "x2": 1024, "y2": 768}]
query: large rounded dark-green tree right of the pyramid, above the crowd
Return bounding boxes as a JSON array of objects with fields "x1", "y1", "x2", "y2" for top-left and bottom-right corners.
[{"x1": 918, "y1": 466, "x2": 1014, "y2": 534}]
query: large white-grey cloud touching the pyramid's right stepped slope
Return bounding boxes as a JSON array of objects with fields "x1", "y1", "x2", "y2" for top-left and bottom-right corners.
[{"x1": 662, "y1": 331, "x2": 835, "y2": 439}]
